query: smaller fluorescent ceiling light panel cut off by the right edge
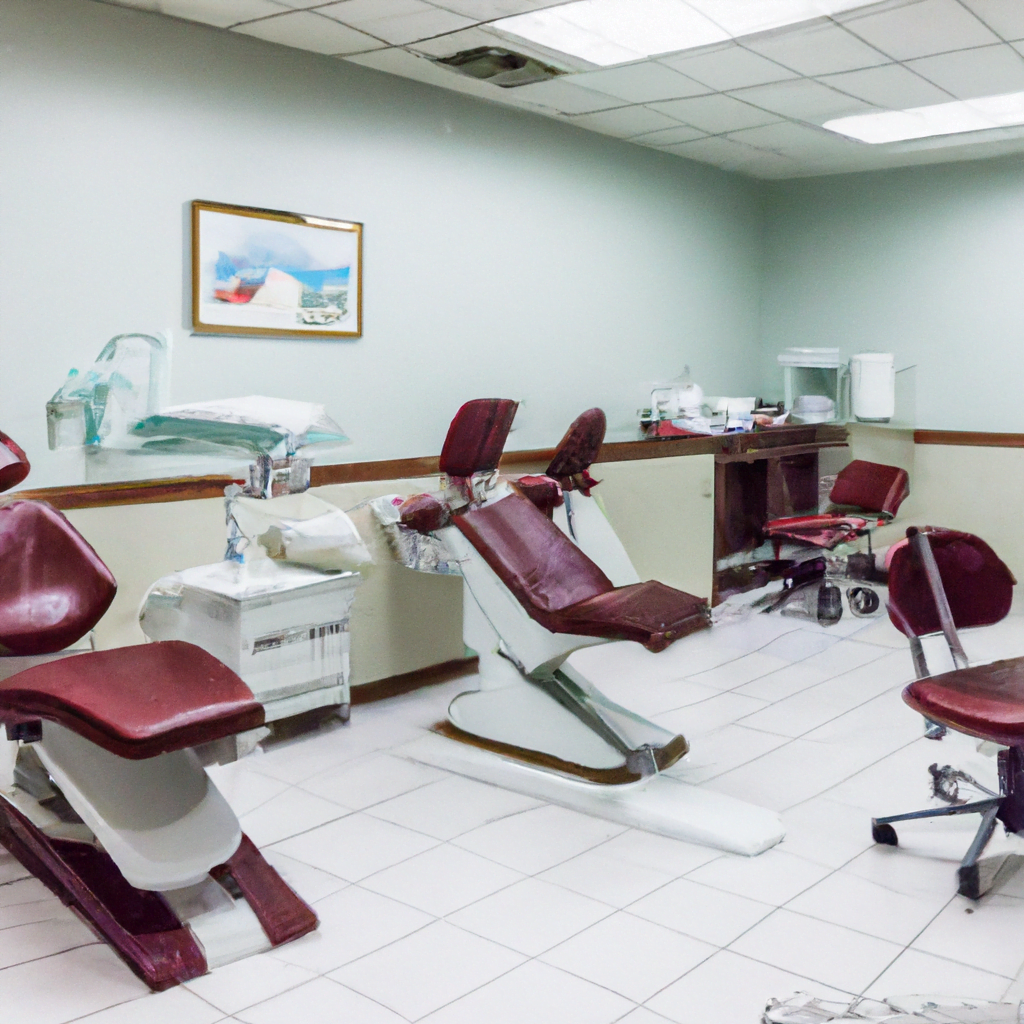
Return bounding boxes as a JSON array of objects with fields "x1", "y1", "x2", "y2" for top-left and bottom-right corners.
[{"x1": 821, "y1": 92, "x2": 1024, "y2": 145}]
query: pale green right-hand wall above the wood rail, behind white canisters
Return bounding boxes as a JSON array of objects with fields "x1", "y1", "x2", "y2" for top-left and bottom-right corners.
[{"x1": 762, "y1": 156, "x2": 1024, "y2": 432}]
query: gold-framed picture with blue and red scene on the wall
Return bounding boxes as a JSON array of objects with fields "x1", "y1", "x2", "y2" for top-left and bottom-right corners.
[{"x1": 191, "y1": 200, "x2": 362, "y2": 338}]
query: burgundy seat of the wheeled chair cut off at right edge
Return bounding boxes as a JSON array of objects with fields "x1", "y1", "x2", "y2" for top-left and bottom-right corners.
[{"x1": 903, "y1": 657, "x2": 1024, "y2": 746}]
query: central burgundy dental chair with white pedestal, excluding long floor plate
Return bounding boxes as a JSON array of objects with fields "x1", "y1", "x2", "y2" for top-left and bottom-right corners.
[{"x1": 402, "y1": 398, "x2": 709, "y2": 781}]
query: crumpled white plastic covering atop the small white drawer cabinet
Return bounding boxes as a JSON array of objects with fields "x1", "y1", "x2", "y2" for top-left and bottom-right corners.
[{"x1": 228, "y1": 494, "x2": 373, "y2": 574}]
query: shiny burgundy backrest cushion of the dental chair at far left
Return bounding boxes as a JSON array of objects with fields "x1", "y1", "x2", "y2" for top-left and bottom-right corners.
[{"x1": 0, "y1": 502, "x2": 117, "y2": 654}]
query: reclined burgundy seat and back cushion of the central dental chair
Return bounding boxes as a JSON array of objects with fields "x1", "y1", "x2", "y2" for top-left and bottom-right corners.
[{"x1": 455, "y1": 495, "x2": 708, "y2": 650}]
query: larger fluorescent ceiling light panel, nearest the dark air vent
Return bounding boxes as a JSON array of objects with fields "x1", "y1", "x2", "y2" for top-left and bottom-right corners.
[{"x1": 489, "y1": 0, "x2": 877, "y2": 68}]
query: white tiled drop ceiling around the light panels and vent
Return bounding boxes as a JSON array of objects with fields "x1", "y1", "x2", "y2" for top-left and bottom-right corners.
[{"x1": 94, "y1": 0, "x2": 1024, "y2": 178}]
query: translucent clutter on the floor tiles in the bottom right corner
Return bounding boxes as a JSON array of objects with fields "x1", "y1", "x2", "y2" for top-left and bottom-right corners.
[{"x1": 762, "y1": 992, "x2": 1024, "y2": 1024}]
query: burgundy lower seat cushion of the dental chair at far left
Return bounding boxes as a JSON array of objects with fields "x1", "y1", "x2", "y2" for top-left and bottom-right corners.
[{"x1": 0, "y1": 640, "x2": 263, "y2": 760}]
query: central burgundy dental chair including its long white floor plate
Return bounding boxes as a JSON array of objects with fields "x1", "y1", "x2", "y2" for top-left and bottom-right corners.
[{"x1": 391, "y1": 398, "x2": 782, "y2": 854}]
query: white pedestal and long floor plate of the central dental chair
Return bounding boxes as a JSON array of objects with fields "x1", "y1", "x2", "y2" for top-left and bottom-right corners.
[{"x1": 415, "y1": 520, "x2": 785, "y2": 856}]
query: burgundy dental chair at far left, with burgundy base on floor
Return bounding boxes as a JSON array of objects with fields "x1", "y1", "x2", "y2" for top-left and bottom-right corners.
[{"x1": 0, "y1": 435, "x2": 316, "y2": 990}]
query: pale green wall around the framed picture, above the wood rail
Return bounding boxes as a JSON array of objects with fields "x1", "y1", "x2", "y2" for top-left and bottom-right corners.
[{"x1": 0, "y1": 0, "x2": 761, "y2": 486}]
